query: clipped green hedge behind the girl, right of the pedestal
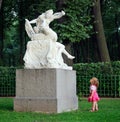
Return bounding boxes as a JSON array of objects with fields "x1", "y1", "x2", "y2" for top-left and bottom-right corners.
[{"x1": 73, "y1": 61, "x2": 120, "y2": 97}]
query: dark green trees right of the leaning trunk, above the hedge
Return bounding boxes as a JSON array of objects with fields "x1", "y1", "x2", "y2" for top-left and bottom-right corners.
[{"x1": 102, "y1": 0, "x2": 120, "y2": 61}]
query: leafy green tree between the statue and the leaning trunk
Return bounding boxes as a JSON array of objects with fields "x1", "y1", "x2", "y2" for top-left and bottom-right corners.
[{"x1": 55, "y1": 0, "x2": 92, "y2": 64}]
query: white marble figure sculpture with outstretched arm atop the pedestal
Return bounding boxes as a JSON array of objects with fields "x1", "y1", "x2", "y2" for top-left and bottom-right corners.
[{"x1": 23, "y1": 10, "x2": 75, "y2": 70}]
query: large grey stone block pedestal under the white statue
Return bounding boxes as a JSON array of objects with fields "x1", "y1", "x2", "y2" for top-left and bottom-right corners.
[{"x1": 14, "y1": 69, "x2": 78, "y2": 113}]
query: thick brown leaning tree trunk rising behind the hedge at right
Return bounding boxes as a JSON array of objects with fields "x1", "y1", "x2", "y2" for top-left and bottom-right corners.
[{"x1": 93, "y1": 0, "x2": 110, "y2": 62}]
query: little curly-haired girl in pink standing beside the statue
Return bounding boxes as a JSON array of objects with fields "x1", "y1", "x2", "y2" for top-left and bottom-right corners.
[{"x1": 88, "y1": 77, "x2": 100, "y2": 112}]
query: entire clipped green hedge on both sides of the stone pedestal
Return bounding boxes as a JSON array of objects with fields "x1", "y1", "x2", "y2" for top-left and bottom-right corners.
[{"x1": 0, "y1": 61, "x2": 120, "y2": 97}]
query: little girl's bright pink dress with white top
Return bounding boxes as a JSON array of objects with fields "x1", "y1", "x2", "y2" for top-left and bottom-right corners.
[{"x1": 88, "y1": 85, "x2": 100, "y2": 102}]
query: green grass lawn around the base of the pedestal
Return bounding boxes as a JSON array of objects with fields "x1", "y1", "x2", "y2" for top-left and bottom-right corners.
[{"x1": 0, "y1": 98, "x2": 120, "y2": 122}]
